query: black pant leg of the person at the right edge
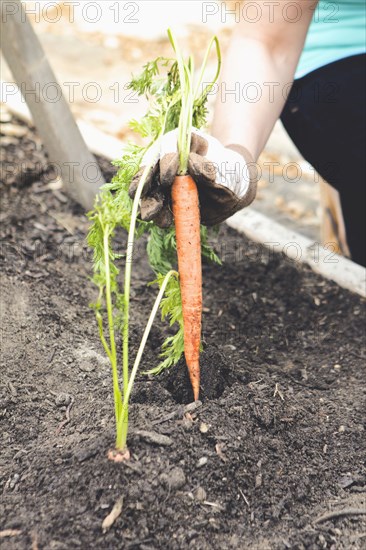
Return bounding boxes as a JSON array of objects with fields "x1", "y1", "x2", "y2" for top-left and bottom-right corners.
[{"x1": 281, "y1": 55, "x2": 366, "y2": 265}]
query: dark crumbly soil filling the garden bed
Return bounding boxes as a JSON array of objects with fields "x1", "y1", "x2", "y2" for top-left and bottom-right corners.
[{"x1": 0, "y1": 118, "x2": 366, "y2": 550}]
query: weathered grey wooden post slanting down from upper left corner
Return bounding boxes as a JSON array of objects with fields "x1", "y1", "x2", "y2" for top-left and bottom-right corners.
[{"x1": 1, "y1": 0, "x2": 104, "y2": 209}]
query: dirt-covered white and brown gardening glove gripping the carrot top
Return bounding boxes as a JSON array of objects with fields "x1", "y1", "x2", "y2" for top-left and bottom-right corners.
[{"x1": 129, "y1": 129, "x2": 257, "y2": 227}]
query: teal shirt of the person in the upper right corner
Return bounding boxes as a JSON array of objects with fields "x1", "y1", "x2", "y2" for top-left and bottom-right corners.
[{"x1": 295, "y1": 0, "x2": 366, "y2": 78}]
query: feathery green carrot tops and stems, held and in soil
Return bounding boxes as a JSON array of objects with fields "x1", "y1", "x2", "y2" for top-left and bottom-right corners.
[{"x1": 88, "y1": 30, "x2": 221, "y2": 459}]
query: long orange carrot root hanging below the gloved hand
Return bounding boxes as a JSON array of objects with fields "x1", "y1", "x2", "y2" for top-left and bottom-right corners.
[{"x1": 172, "y1": 176, "x2": 202, "y2": 400}]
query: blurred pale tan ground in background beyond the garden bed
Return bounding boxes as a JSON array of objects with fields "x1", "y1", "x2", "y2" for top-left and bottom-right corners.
[{"x1": 1, "y1": 0, "x2": 320, "y2": 240}]
